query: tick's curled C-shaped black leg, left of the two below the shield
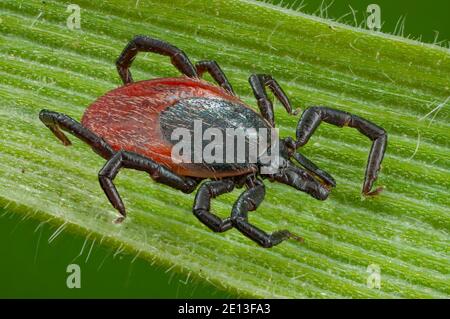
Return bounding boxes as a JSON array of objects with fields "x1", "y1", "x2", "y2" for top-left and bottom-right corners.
[{"x1": 193, "y1": 179, "x2": 235, "y2": 232}]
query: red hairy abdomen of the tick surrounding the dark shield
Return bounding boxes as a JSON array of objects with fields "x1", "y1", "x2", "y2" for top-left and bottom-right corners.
[{"x1": 81, "y1": 78, "x2": 256, "y2": 178}]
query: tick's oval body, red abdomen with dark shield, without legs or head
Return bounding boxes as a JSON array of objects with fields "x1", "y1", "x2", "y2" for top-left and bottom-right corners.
[{"x1": 81, "y1": 77, "x2": 270, "y2": 178}]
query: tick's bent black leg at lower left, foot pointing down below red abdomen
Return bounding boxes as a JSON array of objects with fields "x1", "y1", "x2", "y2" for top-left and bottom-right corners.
[{"x1": 98, "y1": 151, "x2": 198, "y2": 223}]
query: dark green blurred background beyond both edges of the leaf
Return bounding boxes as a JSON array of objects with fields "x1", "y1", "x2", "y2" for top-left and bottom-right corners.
[{"x1": 0, "y1": 0, "x2": 450, "y2": 298}]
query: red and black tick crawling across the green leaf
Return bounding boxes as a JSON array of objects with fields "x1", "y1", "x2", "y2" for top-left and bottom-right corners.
[{"x1": 39, "y1": 36, "x2": 387, "y2": 247}]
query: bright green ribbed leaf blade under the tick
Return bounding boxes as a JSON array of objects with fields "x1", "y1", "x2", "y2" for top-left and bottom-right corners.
[{"x1": 0, "y1": 0, "x2": 450, "y2": 298}]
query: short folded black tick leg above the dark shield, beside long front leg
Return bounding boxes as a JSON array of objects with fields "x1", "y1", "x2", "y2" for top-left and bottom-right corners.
[{"x1": 248, "y1": 74, "x2": 293, "y2": 127}]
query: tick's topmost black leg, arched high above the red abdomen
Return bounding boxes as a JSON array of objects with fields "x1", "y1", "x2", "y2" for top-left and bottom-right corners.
[{"x1": 116, "y1": 35, "x2": 197, "y2": 84}]
